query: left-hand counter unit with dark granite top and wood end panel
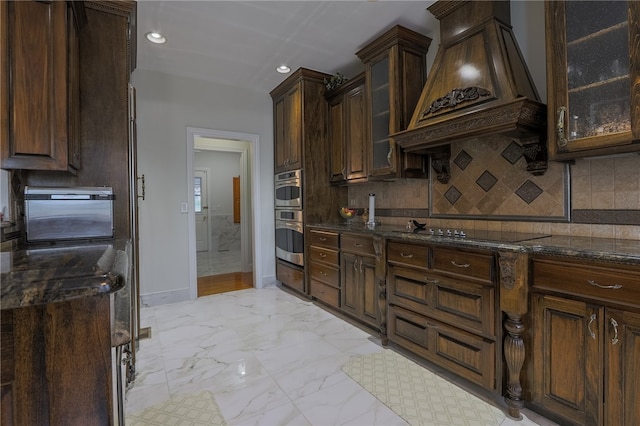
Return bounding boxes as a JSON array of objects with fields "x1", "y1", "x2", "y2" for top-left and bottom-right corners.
[{"x1": 0, "y1": 240, "x2": 131, "y2": 425}]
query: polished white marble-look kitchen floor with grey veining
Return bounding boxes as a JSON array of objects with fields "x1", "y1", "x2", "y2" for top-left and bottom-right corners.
[{"x1": 126, "y1": 287, "x2": 552, "y2": 426}]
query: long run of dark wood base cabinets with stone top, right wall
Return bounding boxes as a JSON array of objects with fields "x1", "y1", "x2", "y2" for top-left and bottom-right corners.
[{"x1": 307, "y1": 222, "x2": 640, "y2": 424}]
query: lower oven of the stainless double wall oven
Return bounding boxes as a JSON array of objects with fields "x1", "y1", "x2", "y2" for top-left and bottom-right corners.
[{"x1": 276, "y1": 210, "x2": 304, "y2": 266}]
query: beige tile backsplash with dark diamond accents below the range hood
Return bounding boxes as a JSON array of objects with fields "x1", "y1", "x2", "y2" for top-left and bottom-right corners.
[{"x1": 349, "y1": 138, "x2": 640, "y2": 240}]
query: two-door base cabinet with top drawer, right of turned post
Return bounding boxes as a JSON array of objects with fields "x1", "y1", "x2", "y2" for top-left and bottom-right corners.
[{"x1": 531, "y1": 258, "x2": 640, "y2": 426}]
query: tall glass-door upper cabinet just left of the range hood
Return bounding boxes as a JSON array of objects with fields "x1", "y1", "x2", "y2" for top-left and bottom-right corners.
[{"x1": 356, "y1": 25, "x2": 431, "y2": 178}]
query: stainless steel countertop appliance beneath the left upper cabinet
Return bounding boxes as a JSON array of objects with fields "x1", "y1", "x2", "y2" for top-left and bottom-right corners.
[{"x1": 24, "y1": 186, "x2": 114, "y2": 242}]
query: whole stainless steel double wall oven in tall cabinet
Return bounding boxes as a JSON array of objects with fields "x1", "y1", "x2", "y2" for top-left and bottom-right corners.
[{"x1": 274, "y1": 170, "x2": 304, "y2": 266}]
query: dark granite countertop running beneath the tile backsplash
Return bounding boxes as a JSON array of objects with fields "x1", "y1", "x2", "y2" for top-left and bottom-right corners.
[{"x1": 308, "y1": 222, "x2": 640, "y2": 265}]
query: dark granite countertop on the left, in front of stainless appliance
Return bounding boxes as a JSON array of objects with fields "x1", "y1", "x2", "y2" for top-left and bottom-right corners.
[{"x1": 0, "y1": 239, "x2": 130, "y2": 345}]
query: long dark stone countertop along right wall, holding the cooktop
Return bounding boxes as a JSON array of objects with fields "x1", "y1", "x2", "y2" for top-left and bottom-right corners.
[{"x1": 307, "y1": 223, "x2": 640, "y2": 265}]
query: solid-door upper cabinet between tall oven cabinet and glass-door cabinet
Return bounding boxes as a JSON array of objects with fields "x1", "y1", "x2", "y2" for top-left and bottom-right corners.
[{"x1": 327, "y1": 74, "x2": 369, "y2": 183}]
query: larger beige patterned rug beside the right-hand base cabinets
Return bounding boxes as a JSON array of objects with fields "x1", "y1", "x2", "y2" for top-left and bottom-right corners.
[{"x1": 342, "y1": 349, "x2": 506, "y2": 426}]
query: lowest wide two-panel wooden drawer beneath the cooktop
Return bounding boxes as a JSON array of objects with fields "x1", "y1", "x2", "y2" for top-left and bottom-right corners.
[{"x1": 387, "y1": 305, "x2": 497, "y2": 390}]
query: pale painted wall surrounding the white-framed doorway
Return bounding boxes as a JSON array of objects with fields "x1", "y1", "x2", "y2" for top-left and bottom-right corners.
[{"x1": 133, "y1": 70, "x2": 275, "y2": 304}]
